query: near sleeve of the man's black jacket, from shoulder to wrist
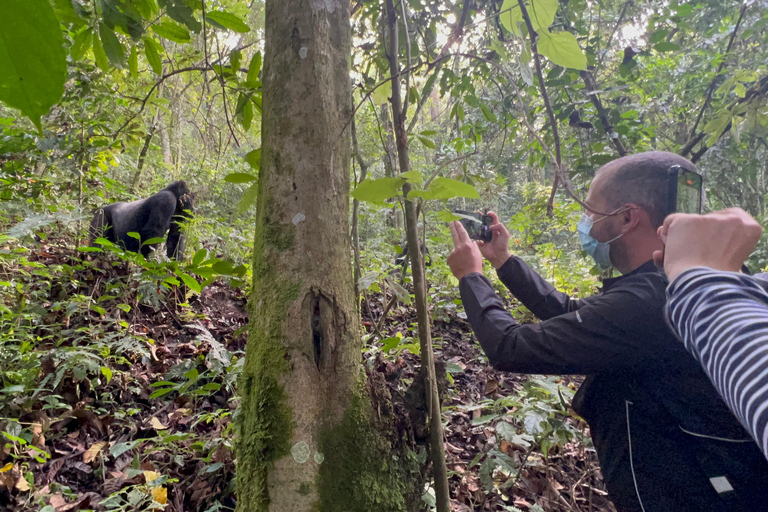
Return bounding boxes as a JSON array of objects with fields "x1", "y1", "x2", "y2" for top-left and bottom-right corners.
[{"x1": 459, "y1": 273, "x2": 668, "y2": 374}]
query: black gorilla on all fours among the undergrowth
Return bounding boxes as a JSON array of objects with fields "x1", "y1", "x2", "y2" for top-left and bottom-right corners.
[{"x1": 90, "y1": 181, "x2": 195, "y2": 261}]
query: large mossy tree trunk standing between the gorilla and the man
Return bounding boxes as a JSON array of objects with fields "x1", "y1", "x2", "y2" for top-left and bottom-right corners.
[{"x1": 237, "y1": 0, "x2": 424, "y2": 512}]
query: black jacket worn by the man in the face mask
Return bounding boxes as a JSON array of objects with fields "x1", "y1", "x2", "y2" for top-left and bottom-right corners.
[{"x1": 459, "y1": 257, "x2": 768, "y2": 512}]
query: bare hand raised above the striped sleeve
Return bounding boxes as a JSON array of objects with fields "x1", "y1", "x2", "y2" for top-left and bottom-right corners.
[{"x1": 653, "y1": 208, "x2": 763, "y2": 281}]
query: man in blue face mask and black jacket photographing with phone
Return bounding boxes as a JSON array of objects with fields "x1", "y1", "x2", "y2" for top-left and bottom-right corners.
[{"x1": 448, "y1": 152, "x2": 768, "y2": 512}]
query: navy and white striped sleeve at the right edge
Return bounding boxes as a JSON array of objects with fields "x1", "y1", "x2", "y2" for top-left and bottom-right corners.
[{"x1": 666, "y1": 268, "x2": 768, "y2": 457}]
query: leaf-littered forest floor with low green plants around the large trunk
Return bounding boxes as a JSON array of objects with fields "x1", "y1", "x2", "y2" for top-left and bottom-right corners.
[{"x1": 0, "y1": 243, "x2": 613, "y2": 512}]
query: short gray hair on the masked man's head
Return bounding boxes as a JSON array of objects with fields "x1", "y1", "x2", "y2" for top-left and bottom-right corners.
[{"x1": 598, "y1": 151, "x2": 696, "y2": 228}]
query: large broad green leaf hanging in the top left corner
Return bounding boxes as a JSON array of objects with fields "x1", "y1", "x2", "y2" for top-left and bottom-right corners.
[{"x1": 0, "y1": 0, "x2": 67, "y2": 133}]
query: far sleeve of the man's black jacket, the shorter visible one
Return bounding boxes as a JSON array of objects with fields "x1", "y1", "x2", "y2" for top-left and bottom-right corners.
[{"x1": 497, "y1": 256, "x2": 584, "y2": 320}]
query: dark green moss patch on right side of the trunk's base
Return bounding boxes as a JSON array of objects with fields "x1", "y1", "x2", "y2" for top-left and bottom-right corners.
[{"x1": 317, "y1": 396, "x2": 419, "y2": 512}]
